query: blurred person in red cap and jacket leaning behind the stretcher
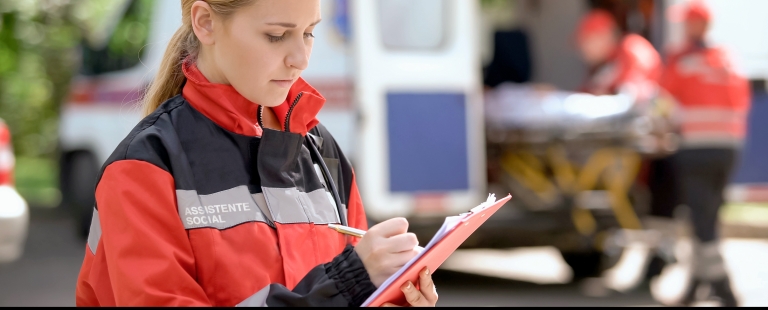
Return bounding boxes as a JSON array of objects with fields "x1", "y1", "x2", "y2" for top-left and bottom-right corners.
[{"x1": 576, "y1": 9, "x2": 662, "y2": 99}]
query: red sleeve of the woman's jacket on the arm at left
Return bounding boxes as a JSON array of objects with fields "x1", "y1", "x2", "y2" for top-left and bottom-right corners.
[{"x1": 91, "y1": 160, "x2": 211, "y2": 306}]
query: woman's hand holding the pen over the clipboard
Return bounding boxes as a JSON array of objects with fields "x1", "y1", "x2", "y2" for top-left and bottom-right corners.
[{"x1": 355, "y1": 218, "x2": 419, "y2": 287}]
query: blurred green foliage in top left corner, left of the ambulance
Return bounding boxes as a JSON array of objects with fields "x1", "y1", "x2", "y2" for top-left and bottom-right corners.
[{"x1": 0, "y1": 0, "x2": 120, "y2": 158}]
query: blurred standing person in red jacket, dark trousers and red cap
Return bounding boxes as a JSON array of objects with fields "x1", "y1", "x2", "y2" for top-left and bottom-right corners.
[{"x1": 661, "y1": 0, "x2": 750, "y2": 306}]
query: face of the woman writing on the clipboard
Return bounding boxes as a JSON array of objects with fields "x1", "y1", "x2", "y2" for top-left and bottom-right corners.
[{"x1": 198, "y1": 0, "x2": 320, "y2": 107}]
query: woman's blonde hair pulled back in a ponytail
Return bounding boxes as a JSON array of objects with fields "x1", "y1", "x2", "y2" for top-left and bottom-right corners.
[{"x1": 141, "y1": 0, "x2": 255, "y2": 116}]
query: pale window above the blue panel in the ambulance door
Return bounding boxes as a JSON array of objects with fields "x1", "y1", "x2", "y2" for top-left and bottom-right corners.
[{"x1": 378, "y1": 0, "x2": 448, "y2": 49}]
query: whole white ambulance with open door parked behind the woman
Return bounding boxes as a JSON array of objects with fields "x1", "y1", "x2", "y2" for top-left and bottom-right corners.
[{"x1": 59, "y1": 0, "x2": 768, "y2": 275}]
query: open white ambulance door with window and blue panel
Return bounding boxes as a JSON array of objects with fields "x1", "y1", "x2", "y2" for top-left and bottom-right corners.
[{"x1": 350, "y1": 0, "x2": 487, "y2": 221}]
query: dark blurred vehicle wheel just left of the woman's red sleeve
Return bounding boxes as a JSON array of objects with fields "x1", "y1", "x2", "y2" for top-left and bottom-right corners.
[{"x1": 62, "y1": 152, "x2": 98, "y2": 238}]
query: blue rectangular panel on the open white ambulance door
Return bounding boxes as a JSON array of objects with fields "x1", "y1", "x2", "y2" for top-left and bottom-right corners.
[{"x1": 387, "y1": 93, "x2": 469, "y2": 192}]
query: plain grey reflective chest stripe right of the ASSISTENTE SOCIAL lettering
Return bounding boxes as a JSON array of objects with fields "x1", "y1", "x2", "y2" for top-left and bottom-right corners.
[{"x1": 262, "y1": 187, "x2": 339, "y2": 224}]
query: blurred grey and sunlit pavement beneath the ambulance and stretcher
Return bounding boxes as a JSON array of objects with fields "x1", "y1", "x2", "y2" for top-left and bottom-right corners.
[{"x1": 0, "y1": 209, "x2": 768, "y2": 307}]
